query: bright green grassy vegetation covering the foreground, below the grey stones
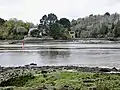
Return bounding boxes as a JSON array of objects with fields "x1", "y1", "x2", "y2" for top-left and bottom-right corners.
[{"x1": 0, "y1": 71, "x2": 120, "y2": 90}]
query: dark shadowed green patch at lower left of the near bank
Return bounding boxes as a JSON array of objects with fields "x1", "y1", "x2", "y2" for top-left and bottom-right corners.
[{"x1": 0, "y1": 74, "x2": 35, "y2": 87}]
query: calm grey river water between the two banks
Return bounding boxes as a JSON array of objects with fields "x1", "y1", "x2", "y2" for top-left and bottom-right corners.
[{"x1": 0, "y1": 42, "x2": 120, "y2": 68}]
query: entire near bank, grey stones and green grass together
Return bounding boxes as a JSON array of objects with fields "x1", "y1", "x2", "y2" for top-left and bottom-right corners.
[{"x1": 0, "y1": 64, "x2": 120, "y2": 90}]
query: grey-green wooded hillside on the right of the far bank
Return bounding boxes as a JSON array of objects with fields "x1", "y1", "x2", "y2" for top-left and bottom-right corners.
[{"x1": 71, "y1": 12, "x2": 120, "y2": 38}]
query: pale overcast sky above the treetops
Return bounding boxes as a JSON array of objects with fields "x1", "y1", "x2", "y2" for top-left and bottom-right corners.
[{"x1": 0, "y1": 0, "x2": 120, "y2": 24}]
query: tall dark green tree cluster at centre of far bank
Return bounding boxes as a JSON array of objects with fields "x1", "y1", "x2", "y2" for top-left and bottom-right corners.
[{"x1": 38, "y1": 13, "x2": 70, "y2": 39}]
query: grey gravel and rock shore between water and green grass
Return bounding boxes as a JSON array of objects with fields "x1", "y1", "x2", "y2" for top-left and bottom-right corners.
[{"x1": 0, "y1": 65, "x2": 120, "y2": 83}]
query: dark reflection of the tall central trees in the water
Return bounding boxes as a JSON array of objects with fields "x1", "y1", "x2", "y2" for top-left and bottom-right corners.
[{"x1": 37, "y1": 50, "x2": 70, "y2": 65}]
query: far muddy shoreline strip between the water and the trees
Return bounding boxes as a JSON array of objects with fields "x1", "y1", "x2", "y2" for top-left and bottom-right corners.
[{"x1": 0, "y1": 38, "x2": 120, "y2": 45}]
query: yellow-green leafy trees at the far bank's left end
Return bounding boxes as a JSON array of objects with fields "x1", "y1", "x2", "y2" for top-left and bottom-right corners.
[{"x1": 0, "y1": 18, "x2": 34, "y2": 39}]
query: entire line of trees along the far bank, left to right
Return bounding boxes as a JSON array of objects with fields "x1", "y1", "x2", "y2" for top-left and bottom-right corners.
[{"x1": 0, "y1": 12, "x2": 120, "y2": 40}]
